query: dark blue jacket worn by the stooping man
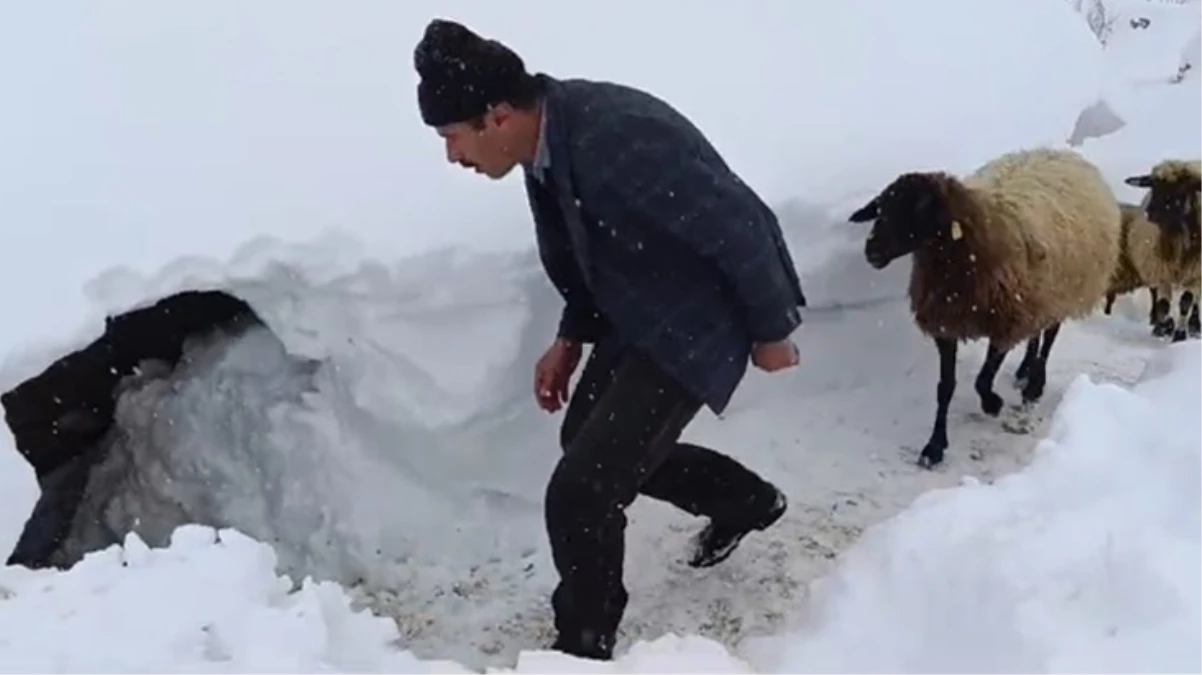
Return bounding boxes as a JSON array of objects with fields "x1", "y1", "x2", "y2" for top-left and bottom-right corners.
[{"x1": 526, "y1": 74, "x2": 805, "y2": 413}]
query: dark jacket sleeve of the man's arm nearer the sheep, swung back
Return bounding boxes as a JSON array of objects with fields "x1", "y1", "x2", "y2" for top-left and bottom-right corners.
[{"x1": 578, "y1": 113, "x2": 804, "y2": 342}]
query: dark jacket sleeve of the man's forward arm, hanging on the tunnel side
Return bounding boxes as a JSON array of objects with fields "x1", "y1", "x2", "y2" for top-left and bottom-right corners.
[{"x1": 525, "y1": 175, "x2": 606, "y2": 342}]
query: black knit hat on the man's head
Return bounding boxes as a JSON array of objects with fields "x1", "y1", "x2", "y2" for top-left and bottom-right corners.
[{"x1": 413, "y1": 19, "x2": 531, "y2": 126}]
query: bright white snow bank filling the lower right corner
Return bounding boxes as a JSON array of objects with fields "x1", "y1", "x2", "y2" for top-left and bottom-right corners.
[{"x1": 749, "y1": 344, "x2": 1202, "y2": 673}]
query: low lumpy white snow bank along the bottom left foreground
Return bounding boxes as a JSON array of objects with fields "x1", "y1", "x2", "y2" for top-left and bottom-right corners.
[{"x1": 0, "y1": 526, "x2": 751, "y2": 675}]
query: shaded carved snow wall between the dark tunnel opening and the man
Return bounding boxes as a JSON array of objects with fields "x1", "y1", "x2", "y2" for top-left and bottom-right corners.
[{"x1": 21, "y1": 239, "x2": 567, "y2": 585}]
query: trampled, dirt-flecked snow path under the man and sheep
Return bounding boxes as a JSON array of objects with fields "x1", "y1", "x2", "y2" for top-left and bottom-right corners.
[{"x1": 334, "y1": 239, "x2": 1161, "y2": 667}]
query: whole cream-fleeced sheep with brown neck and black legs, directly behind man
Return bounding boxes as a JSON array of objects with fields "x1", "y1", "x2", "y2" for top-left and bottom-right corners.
[{"x1": 849, "y1": 148, "x2": 1121, "y2": 468}]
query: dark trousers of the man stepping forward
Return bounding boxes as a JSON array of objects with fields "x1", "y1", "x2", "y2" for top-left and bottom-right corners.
[{"x1": 545, "y1": 347, "x2": 775, "y2": 641}]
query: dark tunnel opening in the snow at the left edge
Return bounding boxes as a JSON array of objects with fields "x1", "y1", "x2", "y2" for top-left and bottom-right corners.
[{"x1": 0, "y1": 291, "x2": 264, "y2": 568}]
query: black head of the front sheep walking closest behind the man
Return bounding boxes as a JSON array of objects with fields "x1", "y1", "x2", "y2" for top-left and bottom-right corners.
[{"x1": 847, "y1": 173, "x2": 956, "y2": 269}]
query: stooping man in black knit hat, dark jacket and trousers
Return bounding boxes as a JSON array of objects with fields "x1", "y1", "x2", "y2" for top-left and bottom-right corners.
[{"x1": 413, "y1": 20, "x2": 805, "y2": 659}]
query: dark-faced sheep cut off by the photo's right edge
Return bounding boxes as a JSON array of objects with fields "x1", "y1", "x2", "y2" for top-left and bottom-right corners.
[{"x1": 1124, "y1": 160, "x2": 1202, "y2": 342}]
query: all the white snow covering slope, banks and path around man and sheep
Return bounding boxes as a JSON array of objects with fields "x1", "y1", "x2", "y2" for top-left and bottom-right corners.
[{"x1": 0, "y1": 0, "x2": 1202, "y2": 675}]
